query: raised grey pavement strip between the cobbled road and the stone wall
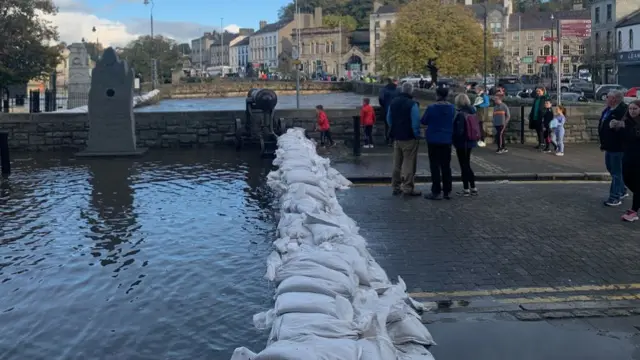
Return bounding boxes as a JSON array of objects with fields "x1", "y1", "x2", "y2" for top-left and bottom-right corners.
[{"x1": 328, "y1": 143, "x2": 605, "y2": 177}]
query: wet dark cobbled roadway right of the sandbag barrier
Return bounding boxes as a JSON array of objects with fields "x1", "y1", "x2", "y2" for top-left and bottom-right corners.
[{"x1": 340, "y1": 183, "x2": 640, "y2": 292}]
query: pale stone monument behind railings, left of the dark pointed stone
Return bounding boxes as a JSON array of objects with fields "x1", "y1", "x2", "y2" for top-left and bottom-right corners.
[{"x1": 67, "y1": 43, "x2": 91, "y2": 109}]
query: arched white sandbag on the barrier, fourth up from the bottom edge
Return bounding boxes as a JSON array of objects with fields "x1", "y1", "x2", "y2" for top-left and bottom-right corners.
[{"x1": 273, "y1": 261, "x2": 358, "y2": 292}]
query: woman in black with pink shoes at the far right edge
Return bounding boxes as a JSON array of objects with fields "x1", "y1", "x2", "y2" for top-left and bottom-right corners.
[{"x1": 609, "y1": 100, "x2": 640, "y2": 222}]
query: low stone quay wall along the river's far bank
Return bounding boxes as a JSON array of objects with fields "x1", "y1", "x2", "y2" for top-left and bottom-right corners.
[{"x1": 161, "y1": 79, "x2": 352, "y2": 99}]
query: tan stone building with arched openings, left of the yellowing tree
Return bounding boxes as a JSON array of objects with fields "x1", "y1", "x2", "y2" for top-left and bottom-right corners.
[{"x1": 291, "y1": 8, "x2": 370, "y2": 77}]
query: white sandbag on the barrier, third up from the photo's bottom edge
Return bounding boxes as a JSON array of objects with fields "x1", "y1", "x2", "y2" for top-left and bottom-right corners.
[{"x1": 274, "y1": 293, "x2": 353, "y2": 321}]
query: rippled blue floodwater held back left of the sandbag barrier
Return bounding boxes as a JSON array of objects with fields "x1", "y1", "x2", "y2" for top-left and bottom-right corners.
[{"x1": 0, "y1": 150, "x2": 276, "y2": 360}]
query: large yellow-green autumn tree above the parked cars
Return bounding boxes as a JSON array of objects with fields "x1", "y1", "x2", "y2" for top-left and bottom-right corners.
[{"x1": 377, "y1": 0, "x2": 495, "y2": 75}]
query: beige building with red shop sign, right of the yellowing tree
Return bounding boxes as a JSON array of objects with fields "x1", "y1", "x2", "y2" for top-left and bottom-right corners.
[{"x1": 504, "y1": 8, "x2": 590, "y2": 76}]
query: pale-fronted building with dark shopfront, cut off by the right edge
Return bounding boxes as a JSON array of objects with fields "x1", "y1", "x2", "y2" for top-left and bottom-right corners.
[{"x1": 616, "y1": 10, "x2": 640, "y2": 88}]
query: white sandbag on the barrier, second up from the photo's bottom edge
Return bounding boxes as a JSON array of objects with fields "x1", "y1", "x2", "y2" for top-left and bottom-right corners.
[{"x1": 268, "y1": 313, "x2": 361, "y2": 344}]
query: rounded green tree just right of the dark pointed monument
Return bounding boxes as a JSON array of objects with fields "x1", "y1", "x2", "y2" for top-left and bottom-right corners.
[{"x1": 120, "y1": 35, "x2": 182, "y2": 83}]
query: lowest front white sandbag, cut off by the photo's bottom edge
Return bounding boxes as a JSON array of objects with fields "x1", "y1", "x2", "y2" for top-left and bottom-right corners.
[{"x1": 253, "y1": 336, "x2": 360, "y2": 360}]
